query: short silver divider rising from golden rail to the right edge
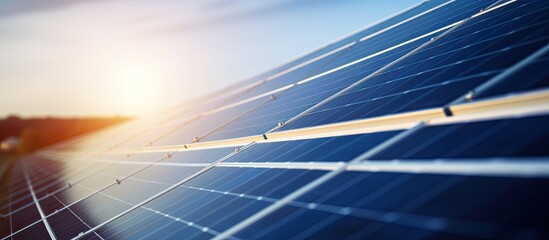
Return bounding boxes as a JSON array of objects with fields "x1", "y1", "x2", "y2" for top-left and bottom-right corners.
[{"x1": 448, "y1": 44, "x2": 549, "y2": 106}]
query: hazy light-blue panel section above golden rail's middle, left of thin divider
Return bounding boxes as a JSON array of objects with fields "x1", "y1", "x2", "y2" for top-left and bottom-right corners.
[{"x1": 204, "y1": 38, "x2": 428, "y2": 140}]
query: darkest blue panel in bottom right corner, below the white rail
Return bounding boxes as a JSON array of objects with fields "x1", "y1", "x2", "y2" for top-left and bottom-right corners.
[{"x1": 235, "y1": 172, "x2": 549, "y2": 239}]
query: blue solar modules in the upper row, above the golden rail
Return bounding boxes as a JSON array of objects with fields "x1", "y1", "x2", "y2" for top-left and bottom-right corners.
[{"x1": 74, "y1": 1, "x2": 547, "y2": 150}]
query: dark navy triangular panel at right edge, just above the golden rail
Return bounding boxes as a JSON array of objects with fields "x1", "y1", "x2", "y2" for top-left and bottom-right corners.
[{"x1": 474, "y1": 53, "x2": 549, "y2": 100}]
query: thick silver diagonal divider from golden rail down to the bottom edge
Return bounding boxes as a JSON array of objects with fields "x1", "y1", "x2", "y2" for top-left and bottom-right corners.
[{"x1": 214, "y1": 122, "x2": 425, "y2": 240}]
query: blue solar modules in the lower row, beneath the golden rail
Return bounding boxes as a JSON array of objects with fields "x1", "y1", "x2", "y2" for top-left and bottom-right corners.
[{"x1": 2, "y1": 112, "x2": 549, "y2": 239}]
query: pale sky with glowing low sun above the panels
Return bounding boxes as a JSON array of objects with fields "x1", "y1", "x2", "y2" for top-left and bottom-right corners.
[{"x1": 0, "y1": 0, "x2": 419, "y2": 117}]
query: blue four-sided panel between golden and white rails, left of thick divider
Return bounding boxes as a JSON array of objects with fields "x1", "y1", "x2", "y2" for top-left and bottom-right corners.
[{"x1": 225, "y1": 131, "x2": 399, "y2": 162}]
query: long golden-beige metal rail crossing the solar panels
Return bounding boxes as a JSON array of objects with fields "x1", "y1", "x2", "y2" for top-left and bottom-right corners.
[{"x1": 43, "y1": 89, "x2": 549, "y2": 156}]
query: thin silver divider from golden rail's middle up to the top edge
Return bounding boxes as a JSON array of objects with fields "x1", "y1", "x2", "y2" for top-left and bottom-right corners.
[{"x1": 269, "y1": 0, "x2": 514, "y2": 133}]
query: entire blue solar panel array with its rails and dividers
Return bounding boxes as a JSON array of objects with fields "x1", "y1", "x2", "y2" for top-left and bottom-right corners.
[{"x1": 0, "y1": 0, "x2": 549, "y2": 239}]
